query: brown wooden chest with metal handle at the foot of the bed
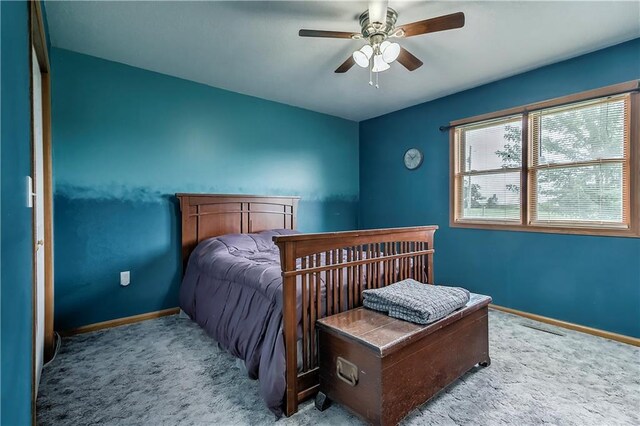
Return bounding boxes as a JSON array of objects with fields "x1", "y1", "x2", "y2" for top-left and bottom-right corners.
[{"x1": 316, "y1": 295, "x2": 491, "y2": 425}]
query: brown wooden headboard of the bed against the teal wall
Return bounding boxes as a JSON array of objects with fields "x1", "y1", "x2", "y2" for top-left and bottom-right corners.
[{"x1": 176, "y1": 193, "x2": 300, "y2": 273}]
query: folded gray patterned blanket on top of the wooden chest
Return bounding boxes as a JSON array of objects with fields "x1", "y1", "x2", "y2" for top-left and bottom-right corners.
[{"x1": 362, "y1": 279, "x2": 469, "y2": 324}]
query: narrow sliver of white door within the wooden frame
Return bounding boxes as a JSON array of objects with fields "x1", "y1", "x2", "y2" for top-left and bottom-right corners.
[{"x1": 31, "y1": 48, "x2": 44, "y2": 394}]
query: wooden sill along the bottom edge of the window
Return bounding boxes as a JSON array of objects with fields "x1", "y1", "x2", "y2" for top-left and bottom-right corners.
[{"x1": 449, "y1": 221, "x2": 640, "y2": 238}]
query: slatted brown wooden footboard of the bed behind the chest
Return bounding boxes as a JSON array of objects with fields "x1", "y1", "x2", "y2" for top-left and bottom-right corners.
[{"x1": 273, "y1": 226, "x2": 438, "y2": 416}]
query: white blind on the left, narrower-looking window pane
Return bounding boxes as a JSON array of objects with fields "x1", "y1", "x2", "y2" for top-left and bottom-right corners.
[{"x1": 455, "y1": 115, "x2": 522, "y2": 222}]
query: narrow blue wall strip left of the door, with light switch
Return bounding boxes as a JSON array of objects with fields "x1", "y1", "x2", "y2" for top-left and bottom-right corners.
[{"x1": 0, "y1": 1, "x2": 33, "y2": 425}]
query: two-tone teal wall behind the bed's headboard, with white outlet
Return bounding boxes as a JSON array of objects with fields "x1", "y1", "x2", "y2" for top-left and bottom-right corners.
[{"x1": 51, "y1": 48, "x2": 359, "y2": 329}]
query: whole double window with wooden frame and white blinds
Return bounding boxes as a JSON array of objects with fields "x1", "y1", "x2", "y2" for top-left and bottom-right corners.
[{"x1": 451, "y1": 82, "x2": 640, "y2": 236}]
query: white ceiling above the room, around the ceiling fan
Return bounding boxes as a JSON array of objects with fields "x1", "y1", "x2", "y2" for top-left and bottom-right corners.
[{"x1": 46, "y1": 0, "x2": 640, "y2": 121}]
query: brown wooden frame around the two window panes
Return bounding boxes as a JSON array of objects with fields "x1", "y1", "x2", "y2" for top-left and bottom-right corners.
[{"x1": 449, "y1": 80, "x2": 640, "y2": 238}]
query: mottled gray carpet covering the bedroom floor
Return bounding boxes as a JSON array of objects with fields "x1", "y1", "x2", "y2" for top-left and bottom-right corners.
[{"x1": 37, "y1": 311, "x2": 640, "y2": 426}]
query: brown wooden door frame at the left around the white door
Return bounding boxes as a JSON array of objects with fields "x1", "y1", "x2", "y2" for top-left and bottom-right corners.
[{"x1": 29, "y1": 0, "x2": 55, "y2": 423}]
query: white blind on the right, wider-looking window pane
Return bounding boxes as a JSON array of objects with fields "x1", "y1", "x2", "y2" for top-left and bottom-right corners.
[{"x1": 529, "y1": 95, "x2": 630, "y2": 228}]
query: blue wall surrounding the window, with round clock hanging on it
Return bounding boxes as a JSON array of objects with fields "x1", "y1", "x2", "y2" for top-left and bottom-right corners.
[{"x1": 360, "y1": 39, "x2": 640, "y2": 337}]
